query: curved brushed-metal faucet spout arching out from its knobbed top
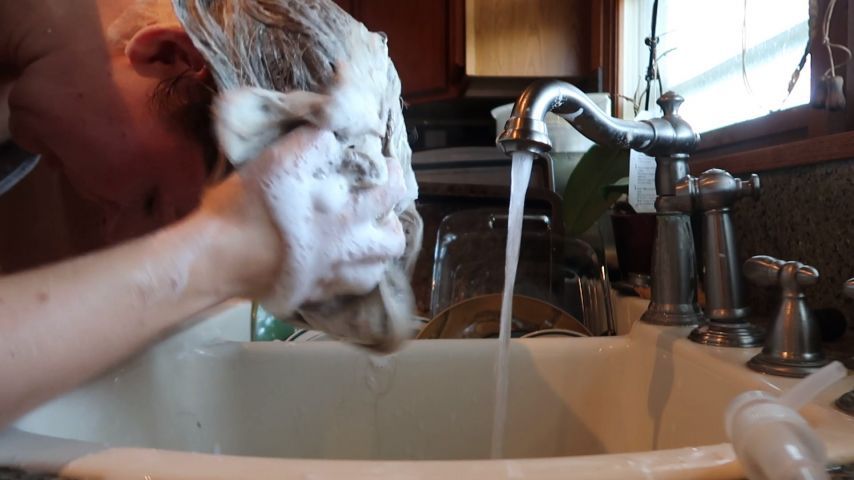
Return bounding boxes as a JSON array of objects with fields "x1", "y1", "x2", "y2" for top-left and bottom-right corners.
[{"x1": 496, "y1": 80, "x2": 699, "y2": 155}]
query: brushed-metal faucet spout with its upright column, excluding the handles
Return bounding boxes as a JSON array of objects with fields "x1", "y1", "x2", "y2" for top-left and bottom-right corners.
[{"x1": 496, "y1": 80, "x2": 703, "y2": 325}]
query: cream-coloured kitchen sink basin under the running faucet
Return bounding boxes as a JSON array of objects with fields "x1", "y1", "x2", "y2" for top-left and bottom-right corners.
[{"x1": 0, "y1": 299, "x2": 854, "y2": 479}]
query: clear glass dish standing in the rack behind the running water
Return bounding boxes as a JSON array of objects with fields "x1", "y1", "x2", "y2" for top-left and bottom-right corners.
[{"x1": 430, "y1": 208, "x2": 615, "y2": 335}]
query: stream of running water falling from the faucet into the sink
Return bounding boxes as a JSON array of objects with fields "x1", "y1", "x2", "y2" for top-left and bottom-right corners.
[{"x1": 490, "y1": 152, "x2": 534, "y2": 458}]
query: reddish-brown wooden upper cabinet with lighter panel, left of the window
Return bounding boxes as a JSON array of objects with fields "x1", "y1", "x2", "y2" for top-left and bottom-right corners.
[{"x1": 336, "y1": 0, "x2": 616, "y2": 103}]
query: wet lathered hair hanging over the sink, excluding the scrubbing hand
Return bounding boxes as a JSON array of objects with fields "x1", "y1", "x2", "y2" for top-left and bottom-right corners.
[{"x1": 173, "y1": 0, "x2": 423, "y2": 340}]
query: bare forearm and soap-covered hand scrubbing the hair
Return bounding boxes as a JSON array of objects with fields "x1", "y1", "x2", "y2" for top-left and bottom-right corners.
[{"x1": 0, "y1": 122, "x2": 405, "y2": 427}]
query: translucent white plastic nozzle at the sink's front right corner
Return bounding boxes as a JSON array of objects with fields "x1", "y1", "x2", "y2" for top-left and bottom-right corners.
[{"x1": 725, "y1": 362, "x2": 848, "y2": 480}]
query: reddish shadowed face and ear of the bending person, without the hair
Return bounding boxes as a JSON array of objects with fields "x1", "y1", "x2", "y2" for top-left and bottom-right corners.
[{"x1": 9, "y1": 0, "x2": 213, "y2": 240}]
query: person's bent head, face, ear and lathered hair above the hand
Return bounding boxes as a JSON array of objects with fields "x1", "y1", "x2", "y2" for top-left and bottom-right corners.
[{"x1": 3, "y1": 0, "x2": 414, "y2": 248}]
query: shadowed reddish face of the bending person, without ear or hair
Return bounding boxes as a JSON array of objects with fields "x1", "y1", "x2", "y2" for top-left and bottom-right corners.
[{"x1": 10, "y1": 0, "x2": 206, "y2": 240}]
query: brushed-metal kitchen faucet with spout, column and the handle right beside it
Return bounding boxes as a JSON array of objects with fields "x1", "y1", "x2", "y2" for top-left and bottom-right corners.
[{"x1": 496, "y1": 80, "x2": 761, "y2": 338}]
